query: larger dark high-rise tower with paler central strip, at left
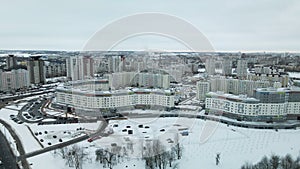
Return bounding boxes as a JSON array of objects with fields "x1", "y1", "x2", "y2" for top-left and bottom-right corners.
[{"x1": 27, "y1": 56, "x2": 46, "y2": 84}]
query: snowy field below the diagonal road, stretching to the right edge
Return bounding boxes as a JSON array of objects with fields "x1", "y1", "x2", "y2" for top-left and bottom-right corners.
[{"x1": 29, "y1": 118, "x2": 300, "y2": 169}]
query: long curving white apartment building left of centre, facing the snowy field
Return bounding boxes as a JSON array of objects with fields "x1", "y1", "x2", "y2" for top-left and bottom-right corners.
[{"x1": 56, "y1": 81, "x2": 175, "y2": 109}]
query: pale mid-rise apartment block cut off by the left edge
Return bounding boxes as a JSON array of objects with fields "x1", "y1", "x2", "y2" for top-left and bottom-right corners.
[{"x1": 0, "y1": 69, "x2": 30, "y2": 91}]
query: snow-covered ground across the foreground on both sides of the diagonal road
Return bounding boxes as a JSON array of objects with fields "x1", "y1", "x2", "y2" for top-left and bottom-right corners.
[{"x1": 0, "y1": 99, "x2": 300, "y2": 169}]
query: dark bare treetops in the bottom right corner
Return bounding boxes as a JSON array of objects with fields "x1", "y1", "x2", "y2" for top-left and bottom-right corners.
[{"x1": 241, "y1": 154, "x2": 300, "y2": 169}]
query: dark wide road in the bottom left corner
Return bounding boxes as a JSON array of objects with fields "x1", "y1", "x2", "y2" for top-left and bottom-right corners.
[{"x1": 0, "y1": 131, "x2": 19, "y2": 169}]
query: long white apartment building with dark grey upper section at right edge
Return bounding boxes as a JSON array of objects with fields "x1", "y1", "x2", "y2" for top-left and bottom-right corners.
[{"x1": 205, "y1": 88, "x2": 300, "y2": 117}]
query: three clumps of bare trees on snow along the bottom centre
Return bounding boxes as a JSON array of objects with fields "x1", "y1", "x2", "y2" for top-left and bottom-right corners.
[{"x1": 54, "y1": 135, "x2": 183, "y2": 169}]
